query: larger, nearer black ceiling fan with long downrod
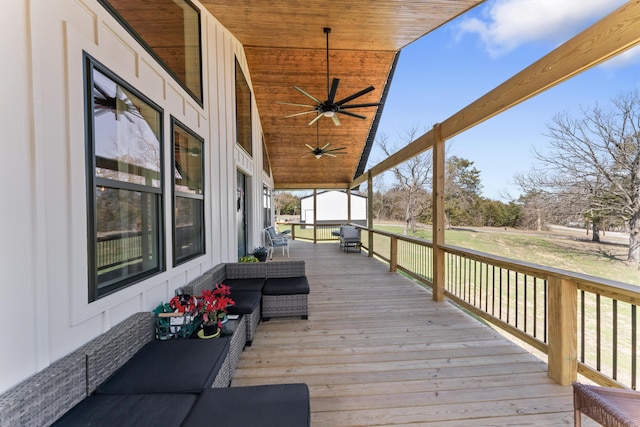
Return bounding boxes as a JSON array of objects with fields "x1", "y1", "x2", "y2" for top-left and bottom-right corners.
[{"x1": 277, "y1": 27, "x2": 380, "y2": 126}]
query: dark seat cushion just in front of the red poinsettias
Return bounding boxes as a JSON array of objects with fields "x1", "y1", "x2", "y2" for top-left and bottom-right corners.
[{"x1": 97, "y1": 338, "x2": 229, "y2": 393}]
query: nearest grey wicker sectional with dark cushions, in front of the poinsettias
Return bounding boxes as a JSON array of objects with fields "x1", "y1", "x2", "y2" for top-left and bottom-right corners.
[{"x1": 0, "y1": 312, "x2": 310, "y2": 427}]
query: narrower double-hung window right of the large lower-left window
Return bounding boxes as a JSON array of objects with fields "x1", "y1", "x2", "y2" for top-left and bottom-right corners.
[{"x1": 171, "y1": 119, "x2": 204, "y2": 265}]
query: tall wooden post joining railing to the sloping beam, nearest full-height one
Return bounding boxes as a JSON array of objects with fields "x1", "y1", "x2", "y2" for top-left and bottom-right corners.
[{"x1": 432, "y1": 123, "x2": 445, "y2": 302}]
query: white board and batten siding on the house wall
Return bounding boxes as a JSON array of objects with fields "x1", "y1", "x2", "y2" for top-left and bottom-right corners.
[{"x1": 0, "y1": 0, "x2": 273, "y2": 393}]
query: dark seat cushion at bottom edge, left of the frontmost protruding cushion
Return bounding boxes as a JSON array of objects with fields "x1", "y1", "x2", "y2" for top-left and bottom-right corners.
[{"x1": 53, "y1": 393, "x2": 198, "y2": 427}]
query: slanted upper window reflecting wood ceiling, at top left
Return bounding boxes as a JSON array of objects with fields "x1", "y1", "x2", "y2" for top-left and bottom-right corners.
[{"x1": 98, "y1": 0, "x2": 202, "y2": 104}]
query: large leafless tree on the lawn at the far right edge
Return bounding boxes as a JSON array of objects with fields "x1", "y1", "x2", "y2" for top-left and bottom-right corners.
[{"x1": 535, "y1": 92, "x2": 640, "y2": 264}]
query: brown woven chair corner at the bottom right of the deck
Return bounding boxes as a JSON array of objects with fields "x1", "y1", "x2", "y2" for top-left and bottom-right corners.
[{"x1": 573, "y1": 383, "x2": 640, "y2": 427}]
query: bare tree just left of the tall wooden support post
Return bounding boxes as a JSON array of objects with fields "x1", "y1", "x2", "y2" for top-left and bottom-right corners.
[{"x1": 377, "y1": 127, "x2": 433, "y2": 235}]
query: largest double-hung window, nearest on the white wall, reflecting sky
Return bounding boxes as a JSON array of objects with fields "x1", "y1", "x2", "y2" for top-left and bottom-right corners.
[{"x1": 85, "y1": 55, "x2": 163, "y2": 301}]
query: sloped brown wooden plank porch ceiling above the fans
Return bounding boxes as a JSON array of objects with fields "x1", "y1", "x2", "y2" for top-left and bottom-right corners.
[{"x1": 201, "y1": 0, "x2": 482, "y2": 189}]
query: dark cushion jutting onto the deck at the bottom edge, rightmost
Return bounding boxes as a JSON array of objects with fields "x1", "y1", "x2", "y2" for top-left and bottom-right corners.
[{"x1": 183, "y1": 384, "x2": 311, "y2": 427}]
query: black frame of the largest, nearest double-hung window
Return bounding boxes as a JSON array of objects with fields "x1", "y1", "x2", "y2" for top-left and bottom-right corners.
[{"x1": 83, "y1": 52, "x2": 166, "y2": 303}]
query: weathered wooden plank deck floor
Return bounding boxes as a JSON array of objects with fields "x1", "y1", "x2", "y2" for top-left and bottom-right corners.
[{"x1": 232, "y1": 241, "x2": 594, "y2": 427}]
